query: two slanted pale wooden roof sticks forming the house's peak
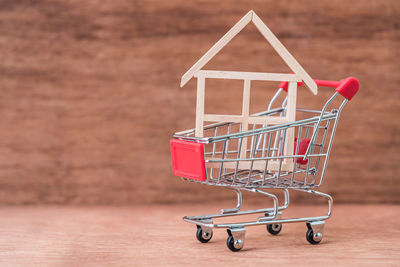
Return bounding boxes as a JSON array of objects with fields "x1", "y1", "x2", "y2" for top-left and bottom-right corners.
[{"x1": 181, "y1": 10, "x2": 318, "y2": 95}]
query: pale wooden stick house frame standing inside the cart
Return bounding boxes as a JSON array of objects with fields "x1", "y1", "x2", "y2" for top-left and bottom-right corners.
[{"x1": 181, "y1": 10, "x2": 318, "y2": 170}]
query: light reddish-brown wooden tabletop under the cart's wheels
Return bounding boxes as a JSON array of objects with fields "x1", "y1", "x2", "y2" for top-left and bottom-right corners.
[{"x1": 0, "y1": 204, "x2": 400, "y2": 266}]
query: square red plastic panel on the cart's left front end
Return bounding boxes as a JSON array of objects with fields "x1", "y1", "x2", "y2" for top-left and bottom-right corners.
[{"x1": 170, "y1": 139, "x2": 206, "y2": 181}]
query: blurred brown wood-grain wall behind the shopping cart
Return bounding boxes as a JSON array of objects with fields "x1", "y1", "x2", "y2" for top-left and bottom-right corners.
[{"x1": 0, "y1": 0, "x2": 400, "y2": 204}]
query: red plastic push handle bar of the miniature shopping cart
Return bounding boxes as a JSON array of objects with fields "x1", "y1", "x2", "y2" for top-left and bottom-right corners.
[{"x1": 279, "y1": 77, "x2": 360, "y2": 100}]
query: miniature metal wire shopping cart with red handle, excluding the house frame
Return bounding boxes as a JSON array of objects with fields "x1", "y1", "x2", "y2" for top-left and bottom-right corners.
[{"x1": 171, "y1": 78, "x2": 358, "y2": 251}]
